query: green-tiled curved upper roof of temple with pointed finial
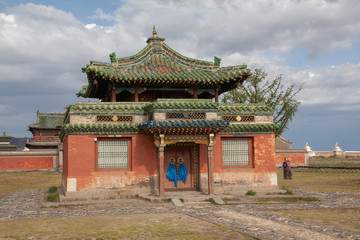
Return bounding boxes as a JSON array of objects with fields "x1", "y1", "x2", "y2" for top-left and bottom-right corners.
[{"x1": 77, "y1": 29, "x2": 251, "y2": 98}]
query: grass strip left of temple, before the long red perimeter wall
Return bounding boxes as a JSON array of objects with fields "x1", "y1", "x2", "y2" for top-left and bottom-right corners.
[{"x1": 0, "y1": 172, "x2": 62, "y2": 197}]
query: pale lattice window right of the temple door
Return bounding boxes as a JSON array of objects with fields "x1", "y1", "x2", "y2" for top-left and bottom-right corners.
[{"x1": 222, "y1": 139, "x2": 250, "y2": 166}]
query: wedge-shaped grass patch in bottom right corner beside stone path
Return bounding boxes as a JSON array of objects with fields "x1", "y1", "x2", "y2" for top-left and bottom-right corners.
[{"x1": 272, "y1": 208, "x2": 360, "y2": 233}]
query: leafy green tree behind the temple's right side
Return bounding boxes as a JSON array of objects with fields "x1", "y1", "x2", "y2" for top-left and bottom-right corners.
[{"x1": 222, "y1": 68, "x2": 302, "y2": 136}]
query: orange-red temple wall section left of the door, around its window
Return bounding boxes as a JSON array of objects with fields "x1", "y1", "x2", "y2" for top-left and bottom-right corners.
[{"x1": 63, "y1": 134, "x2": 157, "y2": 190}]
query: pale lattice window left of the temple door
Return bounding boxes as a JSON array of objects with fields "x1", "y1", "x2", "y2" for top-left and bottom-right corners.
[{"x1": 98, "y1": 140, "x2": 129, "y2": 168}]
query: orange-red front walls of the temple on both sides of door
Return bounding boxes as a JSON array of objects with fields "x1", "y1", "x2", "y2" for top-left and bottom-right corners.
[{"x1": 63, "y1": 134, "x2": 276, "y2": 190}]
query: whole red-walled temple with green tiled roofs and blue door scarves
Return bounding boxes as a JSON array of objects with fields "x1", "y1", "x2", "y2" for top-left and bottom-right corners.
[{"x1": 60, "y1": 27, "x2": 277, "y2": 196}]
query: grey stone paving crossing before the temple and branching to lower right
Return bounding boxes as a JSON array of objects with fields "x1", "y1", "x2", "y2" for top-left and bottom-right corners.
[{"x1": 0, "y1": 189, "x2": 360, "y2": 240}]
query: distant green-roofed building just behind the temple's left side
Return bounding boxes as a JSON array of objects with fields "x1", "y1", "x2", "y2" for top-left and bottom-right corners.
[{"x1": 25, "y1": 111, "x2": 64, "y2": 149}]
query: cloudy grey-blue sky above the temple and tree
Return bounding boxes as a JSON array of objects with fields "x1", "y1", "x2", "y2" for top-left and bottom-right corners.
[{"x1": 0, "y1": 0, "x2": 360, "y2": 150}]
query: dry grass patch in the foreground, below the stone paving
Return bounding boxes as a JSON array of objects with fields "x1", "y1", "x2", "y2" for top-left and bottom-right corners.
[{"x1": 0, "y1": 213, "x2": 252, "y2": 239}]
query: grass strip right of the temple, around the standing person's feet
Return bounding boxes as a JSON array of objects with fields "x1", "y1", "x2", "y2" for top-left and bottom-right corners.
[{"x1": 277, "y1": 170, "x2": 360, "y2": 192}]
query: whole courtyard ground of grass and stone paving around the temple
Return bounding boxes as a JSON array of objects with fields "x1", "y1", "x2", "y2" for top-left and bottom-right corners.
[{"x1": 0, "y1": 166, "x2": 360, "y2": 239}]
